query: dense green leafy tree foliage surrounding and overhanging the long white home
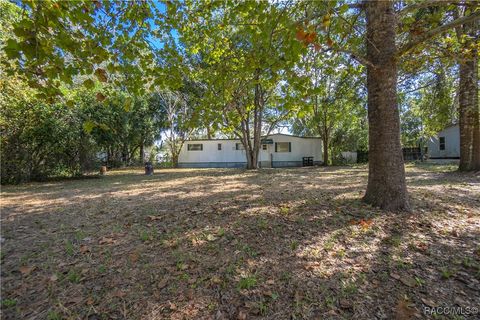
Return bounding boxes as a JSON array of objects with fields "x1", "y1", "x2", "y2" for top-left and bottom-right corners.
[{"x1": 0, "y1": 0, "x2": 472, "y2": 183}]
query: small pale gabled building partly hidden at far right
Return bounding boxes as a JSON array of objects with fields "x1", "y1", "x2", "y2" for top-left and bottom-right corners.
[{"x1": 428, "y1": 124, "x2": 460, "y2": 159}]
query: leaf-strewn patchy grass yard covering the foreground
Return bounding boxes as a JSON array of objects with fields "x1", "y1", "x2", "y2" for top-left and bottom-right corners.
[{"x1": 1, "y1": 163, "x2": 480, "y2": 319}]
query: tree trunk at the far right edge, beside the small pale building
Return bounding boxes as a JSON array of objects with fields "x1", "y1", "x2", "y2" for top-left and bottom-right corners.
[{"x1": 458, "y1": 15, "x2": 480, "y2": 171}]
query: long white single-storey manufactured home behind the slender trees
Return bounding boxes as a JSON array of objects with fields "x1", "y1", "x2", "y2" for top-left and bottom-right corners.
[{"x1": 178, "y1": 133, "x2": 322, "y2": 168}]
